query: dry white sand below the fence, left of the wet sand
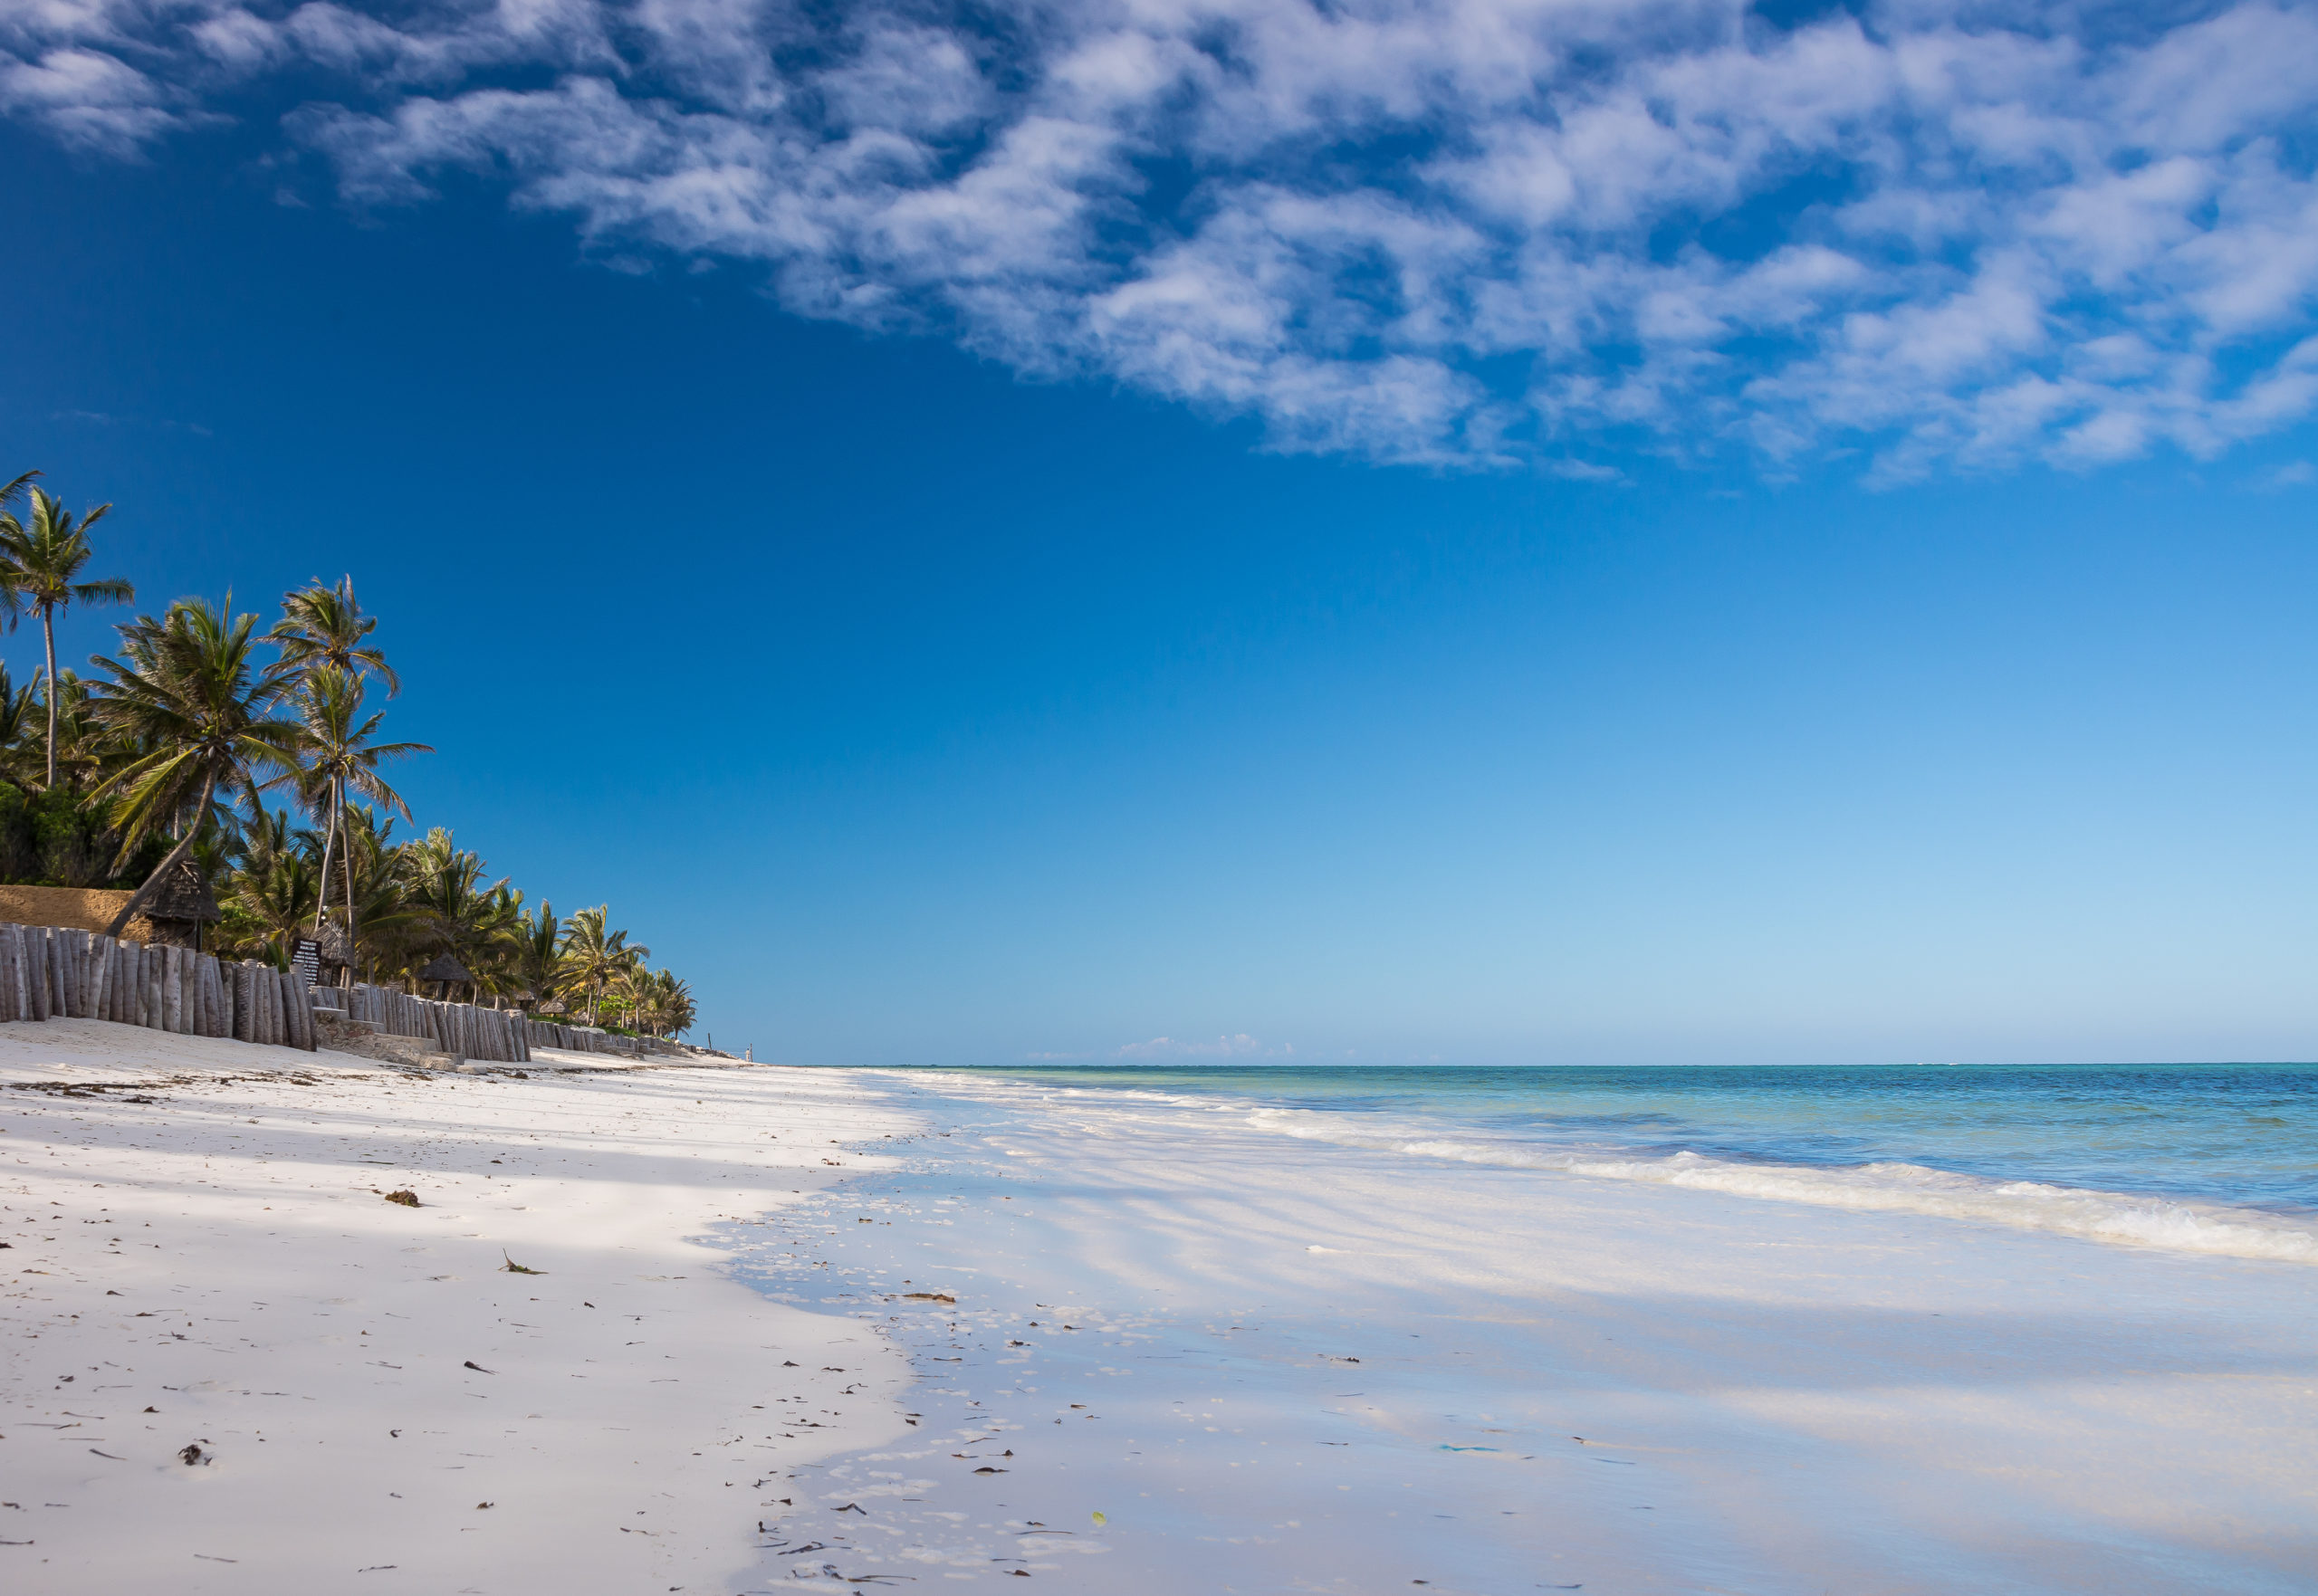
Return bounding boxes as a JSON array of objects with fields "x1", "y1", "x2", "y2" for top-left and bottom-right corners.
[{"x1": 0, "y1": 1021, "x2": 909, "y2": 1596}]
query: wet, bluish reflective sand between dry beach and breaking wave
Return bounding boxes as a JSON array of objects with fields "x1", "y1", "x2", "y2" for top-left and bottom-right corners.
[{"x1": 742, "y1": 1073, "x2": 2318, "y2": 1596}]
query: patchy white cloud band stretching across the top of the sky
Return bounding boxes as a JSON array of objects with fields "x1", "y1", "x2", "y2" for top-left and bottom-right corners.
[{"x1": 0, "y1": 0, "x2": 2318, "y2": 480}]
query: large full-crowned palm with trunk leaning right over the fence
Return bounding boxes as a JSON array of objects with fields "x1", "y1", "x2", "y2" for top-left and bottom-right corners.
[{"x1": 91, "y1": 596, "x2": 302, "y2": 936}]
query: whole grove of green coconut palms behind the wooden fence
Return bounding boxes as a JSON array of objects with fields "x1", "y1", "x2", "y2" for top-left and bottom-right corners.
[{"x1": 0, "y1": 470, "x2": 693, "y2": 1037}]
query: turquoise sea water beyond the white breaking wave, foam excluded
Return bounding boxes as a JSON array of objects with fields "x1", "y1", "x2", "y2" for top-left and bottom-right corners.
[{"x1": 936, "y1": 1063, "x2": 2318, "y2": 1219}]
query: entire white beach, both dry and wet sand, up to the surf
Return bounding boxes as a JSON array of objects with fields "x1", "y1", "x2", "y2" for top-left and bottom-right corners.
[{"x1": 0, "y1": 1021, "x2": 2318, "y2": 1596}]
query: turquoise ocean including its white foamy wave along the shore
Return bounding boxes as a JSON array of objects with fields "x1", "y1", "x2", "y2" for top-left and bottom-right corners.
[{"x1": 941, "y1": 1063, "x2": 2318, "y2": 1263}]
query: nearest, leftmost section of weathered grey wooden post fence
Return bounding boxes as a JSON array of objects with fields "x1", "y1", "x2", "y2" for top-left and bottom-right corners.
[{"x1": 0, "y1": 922, "x2": 313, "y2": 1052}]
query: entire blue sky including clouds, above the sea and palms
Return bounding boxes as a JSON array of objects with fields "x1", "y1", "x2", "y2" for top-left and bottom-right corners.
[{"x1": 0, "y1": 0, "x2": 2318, "y2": 1063}]
